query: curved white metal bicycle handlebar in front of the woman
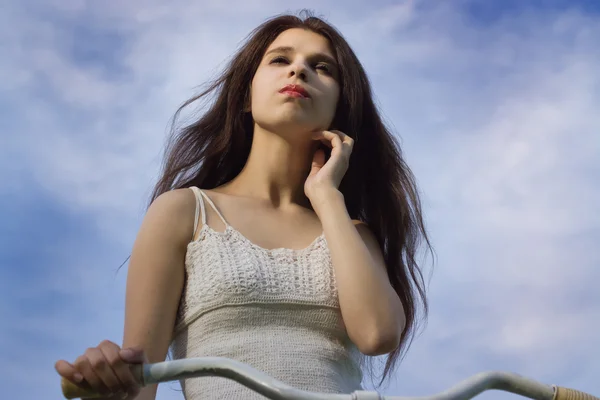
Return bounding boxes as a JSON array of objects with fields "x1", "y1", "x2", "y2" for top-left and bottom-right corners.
[{"x1": 62, "y1": 357, "x2": 600, "y2": 400}]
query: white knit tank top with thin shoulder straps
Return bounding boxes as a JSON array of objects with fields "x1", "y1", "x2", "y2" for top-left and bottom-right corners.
[{"x1": 172, "y1": 187, "x2": 363, "y2": 400}]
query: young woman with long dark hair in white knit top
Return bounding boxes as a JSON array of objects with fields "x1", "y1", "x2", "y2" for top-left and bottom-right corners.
[{"x1": 56, "y1": 10, "x2": 429, "y2": 400}]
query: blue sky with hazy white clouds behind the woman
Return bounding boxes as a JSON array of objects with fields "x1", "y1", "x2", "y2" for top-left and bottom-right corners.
[{"x1": 0, "y1": 0, "x2": 600, "y2": 400}]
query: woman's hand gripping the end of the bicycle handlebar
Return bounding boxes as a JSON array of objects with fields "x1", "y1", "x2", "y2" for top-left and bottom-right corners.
[{"x1": 54, "y1": 340, "x2": 148, "y2": 399}]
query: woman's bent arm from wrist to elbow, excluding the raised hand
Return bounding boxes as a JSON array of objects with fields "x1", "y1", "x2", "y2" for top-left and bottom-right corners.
[{"x1": 314, "y1": 190, "x2": 405, "y2": 356}]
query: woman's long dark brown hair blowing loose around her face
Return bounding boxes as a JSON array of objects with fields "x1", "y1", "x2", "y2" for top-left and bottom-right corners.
[{"x1": 151, "y1": 11, "x2": 431, "y2": 385}]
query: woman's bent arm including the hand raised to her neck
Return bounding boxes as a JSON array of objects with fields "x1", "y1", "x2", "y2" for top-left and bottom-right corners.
[{"x1": 304, "y1": 130, "x2": 406, "y2": 355}]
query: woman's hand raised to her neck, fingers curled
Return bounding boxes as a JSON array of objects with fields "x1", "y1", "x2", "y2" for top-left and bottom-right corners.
[{"x1": 304, "y1": 130, "x2": 354, "y2": 207}]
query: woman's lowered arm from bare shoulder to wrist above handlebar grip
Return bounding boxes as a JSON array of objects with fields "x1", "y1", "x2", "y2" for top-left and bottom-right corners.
[{"x1": 123, "y1": 189, "x2": 195, "y2": 400}]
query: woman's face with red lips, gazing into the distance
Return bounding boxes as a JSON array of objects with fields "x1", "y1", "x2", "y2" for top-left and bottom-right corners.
[{"x1": 250, "y1": 28, "x2": 340, "y2": 137}]
